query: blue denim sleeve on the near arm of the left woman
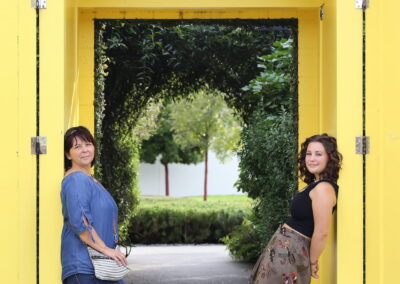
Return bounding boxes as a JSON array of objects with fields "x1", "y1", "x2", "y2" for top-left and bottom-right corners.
[{"x1": 61, "y1": 173, "x2": 93, "y2": 235}]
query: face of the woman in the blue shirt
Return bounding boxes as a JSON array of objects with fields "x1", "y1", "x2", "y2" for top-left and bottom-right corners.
[{"x1": 66, "y1": 137, "x2": 94, "y2": 168}]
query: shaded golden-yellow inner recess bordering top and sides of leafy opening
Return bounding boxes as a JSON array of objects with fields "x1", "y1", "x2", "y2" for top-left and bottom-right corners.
[{"x1": 78, "y1": 8, "x2": 320, "y2": 142}]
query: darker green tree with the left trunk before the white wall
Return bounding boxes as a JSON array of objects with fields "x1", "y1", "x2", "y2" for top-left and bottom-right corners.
[{"x1": 140, "y1": 103, "x2": 202, "y2": 196}]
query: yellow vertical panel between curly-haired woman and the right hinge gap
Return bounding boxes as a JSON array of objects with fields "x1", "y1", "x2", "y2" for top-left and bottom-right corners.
[{"x1": 336, "y1": 0, "x2": 363, "y2": 284}]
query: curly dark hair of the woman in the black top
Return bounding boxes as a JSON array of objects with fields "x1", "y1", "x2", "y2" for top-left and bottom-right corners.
[{"x1": 297, "y1": 133, "x2": 343, "y2": 184}]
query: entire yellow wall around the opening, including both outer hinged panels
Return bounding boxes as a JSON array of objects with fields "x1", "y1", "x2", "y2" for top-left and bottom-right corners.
[{"x1": 5, "y1": 0, "x2": 390, "y2": 284}]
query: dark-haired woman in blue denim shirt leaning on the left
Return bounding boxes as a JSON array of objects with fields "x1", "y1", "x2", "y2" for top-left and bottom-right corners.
[{"x1": 61, "y1": 126, "x2": 127, "y2": 284}]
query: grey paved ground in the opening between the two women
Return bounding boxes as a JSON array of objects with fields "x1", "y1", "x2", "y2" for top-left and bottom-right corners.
[{"x1": 124, "y1": 245, "x2": 252, "y2": 284}]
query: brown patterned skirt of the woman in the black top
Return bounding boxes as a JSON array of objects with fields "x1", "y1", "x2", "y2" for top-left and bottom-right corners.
[{"x1": 249, "y1": 226, "x2": 311, "y2": 284}]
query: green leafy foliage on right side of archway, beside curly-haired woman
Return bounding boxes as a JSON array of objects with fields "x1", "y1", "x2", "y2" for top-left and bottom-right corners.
[{"x1": 224, "y1": 39, "x2": 297, "y2": 260}]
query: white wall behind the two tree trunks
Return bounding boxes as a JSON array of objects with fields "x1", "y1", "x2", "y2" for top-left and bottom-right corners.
[{"x1": 139, "y1": 151, "x2": 243, "y2": 197}]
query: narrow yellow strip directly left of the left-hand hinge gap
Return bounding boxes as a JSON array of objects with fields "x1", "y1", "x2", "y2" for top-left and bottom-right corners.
[{"x1": 17, "y1": 0, "x2": 36, "y2": 283}]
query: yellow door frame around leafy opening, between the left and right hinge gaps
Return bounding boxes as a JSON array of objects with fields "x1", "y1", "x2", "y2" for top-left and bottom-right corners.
[{"x1": 37, "y1": 0, "x2": 363, "y2": 284}]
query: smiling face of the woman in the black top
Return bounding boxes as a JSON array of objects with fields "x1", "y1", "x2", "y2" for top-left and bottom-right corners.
[{"x1": 306, "y1": 142, "x2": 329, "y2": 179}]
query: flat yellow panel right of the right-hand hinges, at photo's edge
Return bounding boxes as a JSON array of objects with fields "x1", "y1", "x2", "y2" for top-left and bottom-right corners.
[{"x1": 366, "y1": 0, "x2": 400, "y2": 283}]
